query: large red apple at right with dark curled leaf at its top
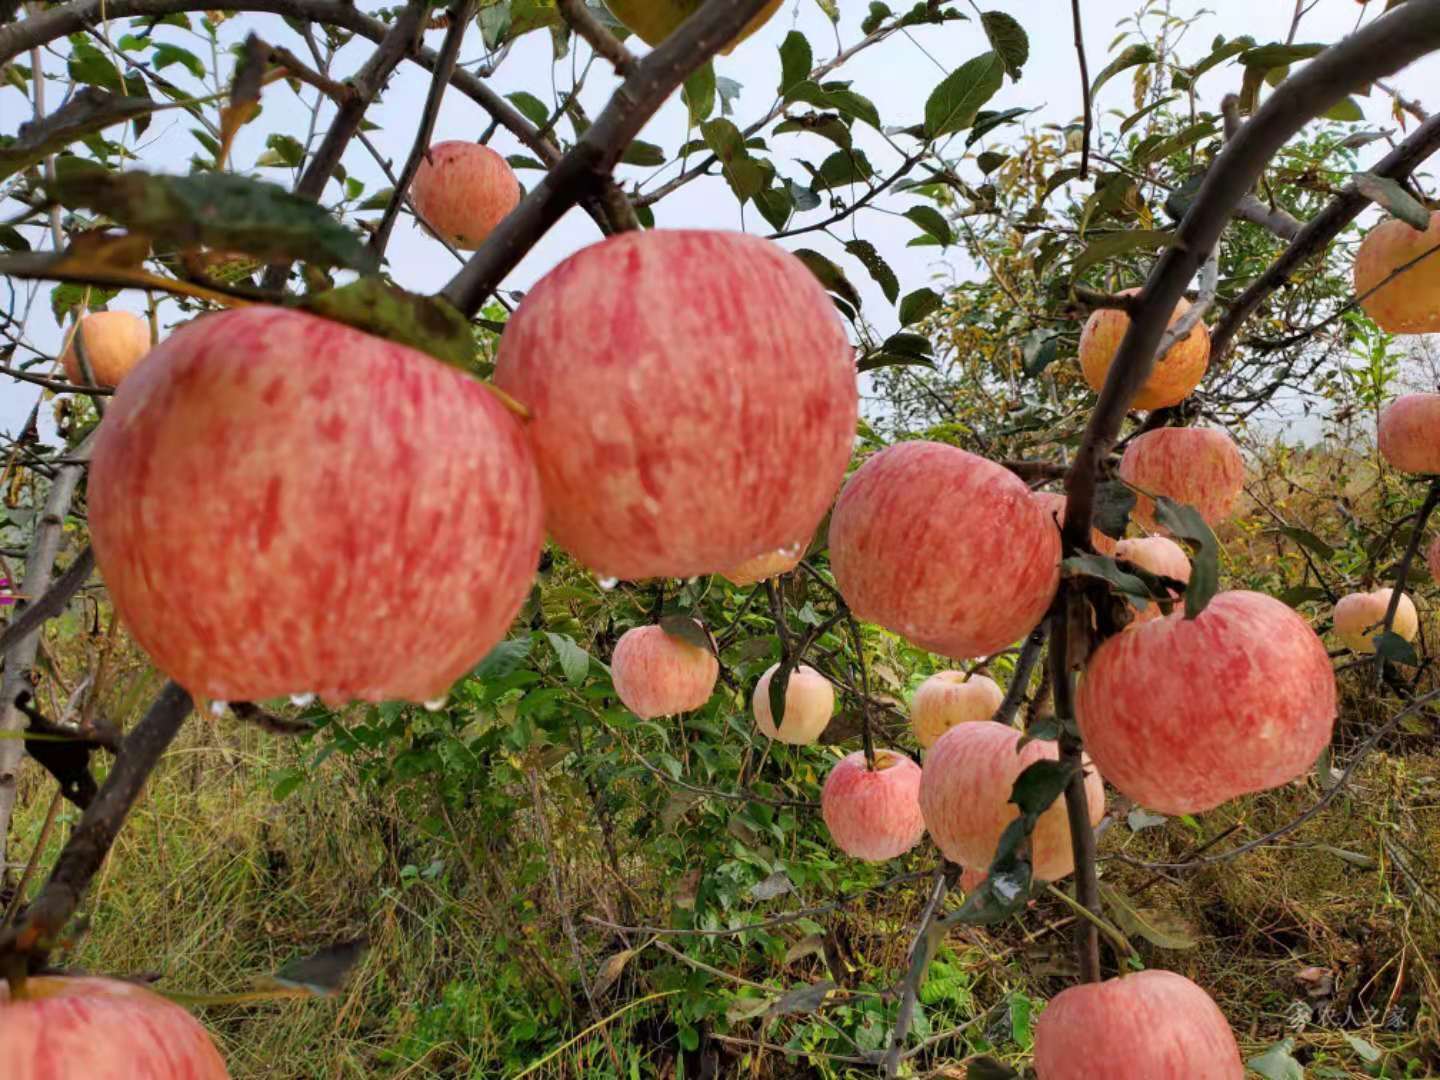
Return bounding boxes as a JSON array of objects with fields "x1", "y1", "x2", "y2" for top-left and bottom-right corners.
[{"x1": 1077, "y1": 592, "x2": 1335, "y2": 831}]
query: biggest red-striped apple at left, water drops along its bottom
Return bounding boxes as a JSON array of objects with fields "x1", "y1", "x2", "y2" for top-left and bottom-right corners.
[{"x1": 89, "y1": 307, "x2": 541, "y2": 703}]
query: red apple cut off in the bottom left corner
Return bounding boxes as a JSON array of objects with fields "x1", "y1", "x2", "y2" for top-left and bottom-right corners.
[{"x1": 0, "y1": 975, "x2": 229, "y2": 1080}]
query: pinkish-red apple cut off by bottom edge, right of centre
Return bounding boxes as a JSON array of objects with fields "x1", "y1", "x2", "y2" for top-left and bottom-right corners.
[{"x1": 1035, "y1": 971, "x2": 1246, "y2": 1080}]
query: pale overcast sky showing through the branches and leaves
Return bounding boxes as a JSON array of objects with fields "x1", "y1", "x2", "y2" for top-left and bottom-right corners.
[{"x1": 0, "y1": 0, "x2": 1440, "y2": 431}]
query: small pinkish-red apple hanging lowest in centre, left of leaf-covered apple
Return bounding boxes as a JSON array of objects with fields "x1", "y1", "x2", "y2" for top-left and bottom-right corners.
[{"x1": 819, "y1": 750, "x2": 924, "y2": 863}]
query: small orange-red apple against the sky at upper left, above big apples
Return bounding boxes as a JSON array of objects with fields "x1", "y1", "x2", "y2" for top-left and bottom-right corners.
[{"x1": 410, "y1": 140, "x2": 520, "y2": 249}]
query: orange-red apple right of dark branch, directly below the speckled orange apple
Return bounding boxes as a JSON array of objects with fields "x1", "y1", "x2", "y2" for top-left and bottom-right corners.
[{"x1": 1120, "y1": 428, "x2": 1246, "y2": 531}]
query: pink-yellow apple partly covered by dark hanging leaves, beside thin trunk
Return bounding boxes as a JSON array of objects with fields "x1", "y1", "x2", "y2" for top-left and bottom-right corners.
[{"x1": 920, "y1": 720, "x2": 1104, "y2": 881}]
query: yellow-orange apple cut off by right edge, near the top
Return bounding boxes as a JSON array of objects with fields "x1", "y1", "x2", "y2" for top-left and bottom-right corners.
[{"x1": 1355, "y1": 213, "x2": 1440, "y2": 334}]
